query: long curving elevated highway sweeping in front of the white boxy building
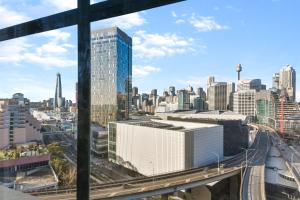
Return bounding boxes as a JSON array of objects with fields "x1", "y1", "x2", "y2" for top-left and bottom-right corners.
[{"x1": 29, "y1": 127, "x2": 264, "y2": 200}]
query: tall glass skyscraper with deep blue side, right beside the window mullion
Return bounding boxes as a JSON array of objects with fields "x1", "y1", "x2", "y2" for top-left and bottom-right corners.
[{"x1": 91, "y1": 27, "x2": 132, "y2": 127}]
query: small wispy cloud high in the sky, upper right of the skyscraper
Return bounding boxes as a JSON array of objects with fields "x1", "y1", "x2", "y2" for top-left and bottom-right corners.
[{"x1": 189, "y1": 15, "x2": 228, "y2": 32}]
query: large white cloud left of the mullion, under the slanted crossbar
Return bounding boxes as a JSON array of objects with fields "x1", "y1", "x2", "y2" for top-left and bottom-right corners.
[{"x1": 0, "y1": 30, "x2": 77, "y2": 69}]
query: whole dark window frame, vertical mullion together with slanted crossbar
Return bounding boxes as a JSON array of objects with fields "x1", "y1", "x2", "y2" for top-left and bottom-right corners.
[{"x1": 0, "y1": 0, "x2": 186, "y2": 200}]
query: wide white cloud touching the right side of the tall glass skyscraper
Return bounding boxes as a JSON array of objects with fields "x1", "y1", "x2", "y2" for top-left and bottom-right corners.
[{"x1": 133, "y1": 31, "x2": 195, "y2": 58}]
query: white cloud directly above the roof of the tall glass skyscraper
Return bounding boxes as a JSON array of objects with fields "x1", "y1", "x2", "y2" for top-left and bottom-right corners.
[{"x1": 100, "y1": 13, "x2": 146, "y2": 29}]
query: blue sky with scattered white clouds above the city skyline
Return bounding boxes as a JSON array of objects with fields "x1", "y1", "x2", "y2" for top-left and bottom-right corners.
[{"x1": 0, "y1": 0, "x2": 300, "y2": 101}]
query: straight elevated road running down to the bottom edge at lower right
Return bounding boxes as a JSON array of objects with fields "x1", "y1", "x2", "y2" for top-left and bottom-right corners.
[{"x1": 240, "y1": 132, "x2": 271, "y2": 200}]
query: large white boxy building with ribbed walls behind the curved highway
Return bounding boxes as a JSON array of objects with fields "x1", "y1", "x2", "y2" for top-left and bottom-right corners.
[{"x1": 108, "y1": 120, "x2": 223, "y2": 176}]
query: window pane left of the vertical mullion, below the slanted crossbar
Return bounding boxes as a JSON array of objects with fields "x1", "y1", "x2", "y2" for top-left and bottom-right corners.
[{"x1": 0, "y1": 27, "x2": 77, "y2": 199}]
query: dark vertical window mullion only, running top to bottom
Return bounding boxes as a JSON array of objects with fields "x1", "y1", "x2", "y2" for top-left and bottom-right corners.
[{"x1": 77, "y1": 0, "x2": 91, "y2": 200}]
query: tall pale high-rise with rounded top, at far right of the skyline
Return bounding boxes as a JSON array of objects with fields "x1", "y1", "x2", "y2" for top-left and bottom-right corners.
[{"x1": 279, "y1": 65, "x2": 296, "y2": 101}]
